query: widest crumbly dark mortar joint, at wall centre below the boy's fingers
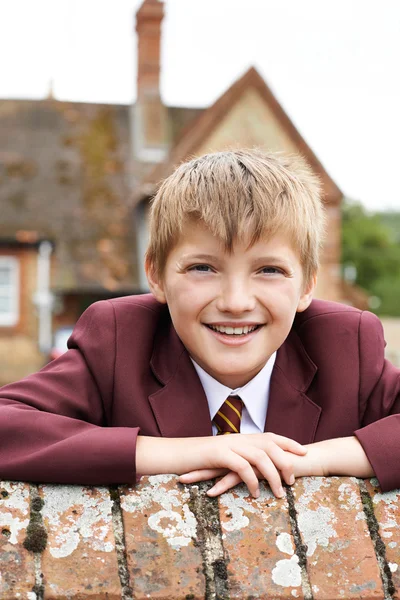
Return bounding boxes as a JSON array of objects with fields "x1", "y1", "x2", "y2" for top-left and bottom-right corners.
[{"x1": 188, "y1": 482, "x2": 230, "y2": 600}]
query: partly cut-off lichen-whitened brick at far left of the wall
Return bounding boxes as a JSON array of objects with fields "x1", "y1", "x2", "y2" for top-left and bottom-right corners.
[{"x1": 0, "y1": 481, "x2": 35, "y2": 600}]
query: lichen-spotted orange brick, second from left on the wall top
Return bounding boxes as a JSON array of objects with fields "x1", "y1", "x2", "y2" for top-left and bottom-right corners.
[{"x1": 39, "y1": 485, "x2": 121, "y2": 600}]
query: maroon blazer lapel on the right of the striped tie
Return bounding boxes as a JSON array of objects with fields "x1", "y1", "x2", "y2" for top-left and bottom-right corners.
[{"x1": 264, "y1": 330, "x2": 321, "y2": 444}]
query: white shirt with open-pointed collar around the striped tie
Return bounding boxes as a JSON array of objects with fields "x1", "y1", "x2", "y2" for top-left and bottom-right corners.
[{"x1": 191, "y1": 352, "x2": 276, "y2": 435}]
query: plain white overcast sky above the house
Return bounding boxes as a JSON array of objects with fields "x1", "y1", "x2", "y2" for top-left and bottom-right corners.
[{"x1": 0, "y1": 0, "x2": 400, "y2": 210}]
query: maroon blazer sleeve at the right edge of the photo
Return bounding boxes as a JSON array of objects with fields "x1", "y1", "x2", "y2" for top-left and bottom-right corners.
[{"x1": 355, "y1": 312, "x2": 400, "y2": 491}]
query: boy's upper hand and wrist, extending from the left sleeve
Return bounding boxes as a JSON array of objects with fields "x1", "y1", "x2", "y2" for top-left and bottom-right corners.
[{"x1": 136, "y1": 433, "x2": 307, "y2": 498}]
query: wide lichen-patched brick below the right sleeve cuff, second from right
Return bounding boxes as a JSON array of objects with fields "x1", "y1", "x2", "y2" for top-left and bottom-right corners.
[{"x1": 294, "y1": 477, "x2": 383, "y2": 600}]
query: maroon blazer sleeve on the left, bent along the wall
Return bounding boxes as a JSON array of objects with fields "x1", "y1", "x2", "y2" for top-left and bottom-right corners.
[{"x1": 0, "y1": 301, "x2": 139, "y2": 485}]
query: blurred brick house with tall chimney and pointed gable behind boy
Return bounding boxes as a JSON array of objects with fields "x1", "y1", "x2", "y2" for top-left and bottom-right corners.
[{"x1": 0, "y1": 0, "x2": 351, "y2": 384}]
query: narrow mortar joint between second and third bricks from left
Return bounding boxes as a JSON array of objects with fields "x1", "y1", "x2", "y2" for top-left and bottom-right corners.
[{"x1": 109, "y1": 486, "x2": 135, "y2": 600}]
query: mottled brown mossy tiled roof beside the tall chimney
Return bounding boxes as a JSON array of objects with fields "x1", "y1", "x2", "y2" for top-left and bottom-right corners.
[{"x1": 0, "y1": 100, "x2": 199, "y2": 291}]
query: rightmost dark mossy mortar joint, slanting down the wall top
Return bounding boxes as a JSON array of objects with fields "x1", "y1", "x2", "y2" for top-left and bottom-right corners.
[{"x1": 358, "y1": 479, "x2": 396, "y2": 600}]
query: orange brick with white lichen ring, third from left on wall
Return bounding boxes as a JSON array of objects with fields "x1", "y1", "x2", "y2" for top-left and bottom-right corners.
[{"x1": 121, "y1": 475, "x2": 205, "y2": 600}]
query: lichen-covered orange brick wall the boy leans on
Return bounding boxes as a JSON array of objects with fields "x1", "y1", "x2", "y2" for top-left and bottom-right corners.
[{"x1": 0, "y1": 475, "x2": 400, "y2": 600}]
